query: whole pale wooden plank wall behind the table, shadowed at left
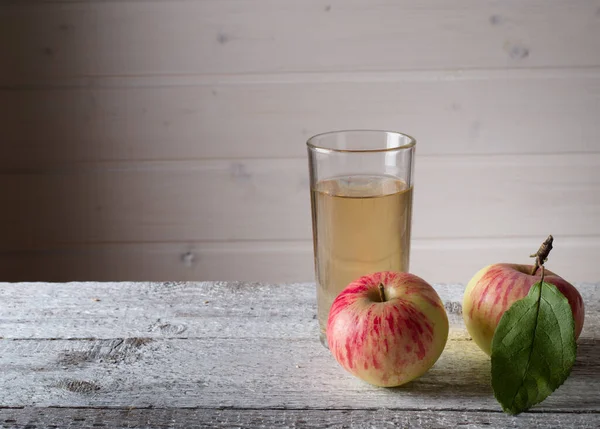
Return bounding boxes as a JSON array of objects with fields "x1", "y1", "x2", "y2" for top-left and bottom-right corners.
[{"x1": 0, "y1": 0, "x2": 600, "y2": 282}]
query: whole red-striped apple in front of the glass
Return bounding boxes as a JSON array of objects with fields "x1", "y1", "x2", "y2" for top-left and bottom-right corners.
[{"x1": 327, "y1": 272, "x2": 448, "y2": 387}]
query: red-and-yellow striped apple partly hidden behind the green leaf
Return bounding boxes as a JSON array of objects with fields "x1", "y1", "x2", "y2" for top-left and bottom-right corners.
[{"x1": 462, "y1": 264, "x2": 585, "y2": 355}]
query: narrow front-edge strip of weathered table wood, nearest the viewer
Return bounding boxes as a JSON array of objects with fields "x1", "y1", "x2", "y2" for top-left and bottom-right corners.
[{"x1": 0, "y1": 407, "x2": 600, "y2": 429}]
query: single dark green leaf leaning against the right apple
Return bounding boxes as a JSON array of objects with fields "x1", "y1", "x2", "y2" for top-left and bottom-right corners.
[{"x1": 492, "y1": 282, "x2": 577, "y2": 414}]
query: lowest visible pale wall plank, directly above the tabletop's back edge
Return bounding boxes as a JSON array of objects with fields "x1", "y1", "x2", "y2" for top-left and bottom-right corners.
[{"x1": 0, "y1": 236, "x2": 600, "y2": 283}]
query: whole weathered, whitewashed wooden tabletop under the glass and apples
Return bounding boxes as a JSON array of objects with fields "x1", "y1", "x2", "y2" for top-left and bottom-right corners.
[{"x1": 0, "y1": 282, "x2": 600, "y2": 428}]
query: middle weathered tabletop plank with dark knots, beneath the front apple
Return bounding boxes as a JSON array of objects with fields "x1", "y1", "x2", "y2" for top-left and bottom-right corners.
[{"x1": 0, "y1": 336, "x2": 600, "y2": 412}]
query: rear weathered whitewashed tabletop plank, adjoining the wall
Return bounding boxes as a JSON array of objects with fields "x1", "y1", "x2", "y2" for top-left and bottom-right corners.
[{"x1": 0, "y1": 282, "x2": 600, "y2": 340}]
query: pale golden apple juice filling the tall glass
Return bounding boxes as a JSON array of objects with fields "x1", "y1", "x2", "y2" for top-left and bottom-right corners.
[{"x1": 311, "y1": 176, "x2": 412, "y2": 344}]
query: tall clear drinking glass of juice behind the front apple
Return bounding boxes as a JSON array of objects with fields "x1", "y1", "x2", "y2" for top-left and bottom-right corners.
[{"x1": 307, "y1": 130, "x2": 416, "y2": 345}]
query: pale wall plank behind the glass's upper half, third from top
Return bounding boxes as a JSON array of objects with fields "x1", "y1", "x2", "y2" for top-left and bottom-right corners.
[{"x1": 0, "y1": 153, "x2": 600, "y2": 246}]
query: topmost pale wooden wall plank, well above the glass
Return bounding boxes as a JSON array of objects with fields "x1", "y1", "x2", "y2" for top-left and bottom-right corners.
[{"x1": 0, "y1": 0, "x2": 600, "y2": 84}]
